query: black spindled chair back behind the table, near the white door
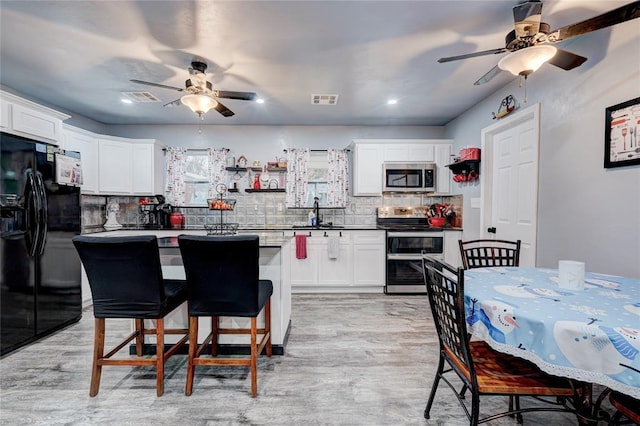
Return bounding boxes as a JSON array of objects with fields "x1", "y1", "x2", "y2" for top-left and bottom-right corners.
[{"x1": 458, "y1": 240, "x2": 521, "y2": 269}]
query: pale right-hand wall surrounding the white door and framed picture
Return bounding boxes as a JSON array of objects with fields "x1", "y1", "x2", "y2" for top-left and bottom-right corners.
[{"x1": 445, "y1": 21, "x2": 640, "y2": 278}]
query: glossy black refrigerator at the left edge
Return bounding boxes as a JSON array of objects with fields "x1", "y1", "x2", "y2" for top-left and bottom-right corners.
[{"x1": 0, "y1": 132, "x2": 82, "y2": 356}]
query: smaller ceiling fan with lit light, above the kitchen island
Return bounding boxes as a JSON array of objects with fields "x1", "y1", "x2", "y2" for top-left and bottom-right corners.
[{"x1": 129, "y1": 60, "x2": 258, "y2": 118}]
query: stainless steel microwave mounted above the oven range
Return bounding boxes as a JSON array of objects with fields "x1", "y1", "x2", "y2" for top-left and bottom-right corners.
[{"x1": 382, "y1": 161, "x2": 437, "y2": 192}]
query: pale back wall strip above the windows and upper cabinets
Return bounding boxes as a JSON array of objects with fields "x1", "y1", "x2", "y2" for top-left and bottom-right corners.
[{"x1": 107, "y1": 125, "x2": 444, "y2": 164}]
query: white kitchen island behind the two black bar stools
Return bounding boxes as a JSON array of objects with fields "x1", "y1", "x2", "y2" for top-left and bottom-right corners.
[{"x1": 83, "y1": 230, "x2": 291, "y2": 355}]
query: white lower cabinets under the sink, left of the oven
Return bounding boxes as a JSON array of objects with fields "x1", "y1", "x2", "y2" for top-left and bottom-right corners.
[{"x1": 287, "y1": 230, "x2": 385, "y2": 293}]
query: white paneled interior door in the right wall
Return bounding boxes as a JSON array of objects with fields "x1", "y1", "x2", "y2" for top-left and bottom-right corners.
[{"x1": 480, "y1": 105, "x2": 540, "y2": 266}]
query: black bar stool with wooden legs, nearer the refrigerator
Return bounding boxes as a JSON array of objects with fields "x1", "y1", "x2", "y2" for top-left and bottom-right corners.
[{"x1": 72, "y1": 235, "x2": 188, "y2": 397}]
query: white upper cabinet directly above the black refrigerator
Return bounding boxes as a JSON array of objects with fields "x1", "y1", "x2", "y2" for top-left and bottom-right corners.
[{"x1": 0, "y1": 91, "x2": 70, "y2": 144}]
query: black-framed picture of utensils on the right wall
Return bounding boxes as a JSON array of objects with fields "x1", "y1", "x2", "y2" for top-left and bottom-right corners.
[{"x1": 604, "y1": 98, "x2": 640, "y2": 168}]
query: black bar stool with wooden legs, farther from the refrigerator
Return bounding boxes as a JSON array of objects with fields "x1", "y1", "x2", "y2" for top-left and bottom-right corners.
[{"x1": 178, "y1": 235, "x2": 273, "y2": 397}]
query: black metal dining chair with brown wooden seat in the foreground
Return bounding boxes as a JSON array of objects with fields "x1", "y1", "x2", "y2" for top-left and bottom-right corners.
[{"x1": 422, "y1": 254, "x2": 586, "y2": 425}]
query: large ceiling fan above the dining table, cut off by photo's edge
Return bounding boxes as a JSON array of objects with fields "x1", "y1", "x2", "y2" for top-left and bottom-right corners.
[{"x1": 438, "y1": 0, "x2": 640, "y2": 85}]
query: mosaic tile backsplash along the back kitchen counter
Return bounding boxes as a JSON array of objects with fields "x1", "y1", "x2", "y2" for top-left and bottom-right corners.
[{"x1": 82, "y1": 192, "x2": 462, "y2": 233}]
